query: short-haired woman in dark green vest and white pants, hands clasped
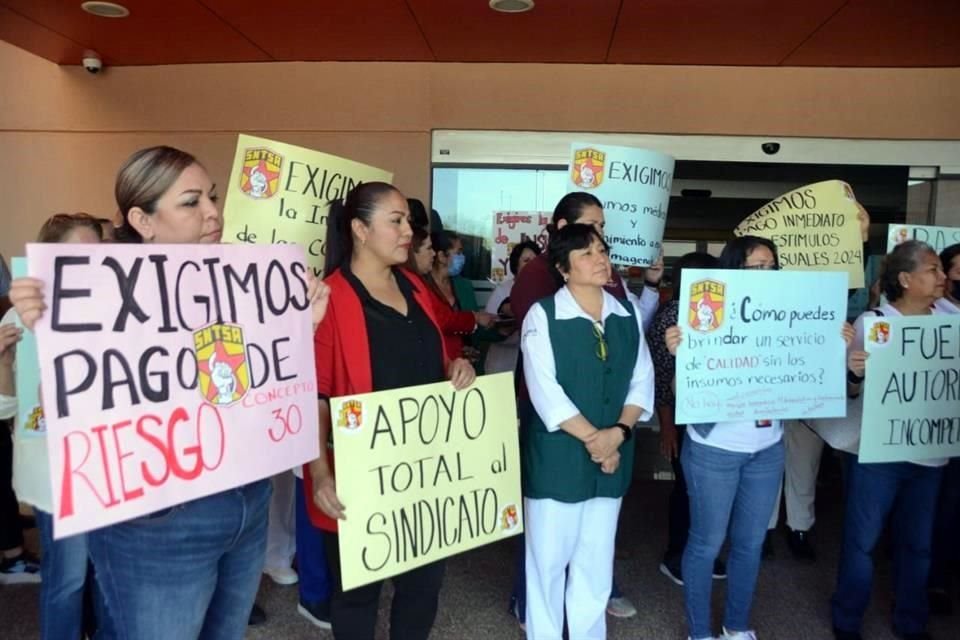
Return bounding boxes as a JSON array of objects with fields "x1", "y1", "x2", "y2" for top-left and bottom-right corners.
[{"x1": 521, "y1": 224, "x2": 653, "y2": 640}]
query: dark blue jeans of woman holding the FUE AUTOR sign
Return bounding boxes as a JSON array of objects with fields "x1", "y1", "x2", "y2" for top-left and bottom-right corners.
[{"x1": 831, "y1": 454, "x2": 943, "y2": 633}]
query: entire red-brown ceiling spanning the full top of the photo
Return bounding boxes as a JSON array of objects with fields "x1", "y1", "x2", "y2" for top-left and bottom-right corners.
[{"x1": 0, "y1": 0, "x2": 960, "y2": 67}]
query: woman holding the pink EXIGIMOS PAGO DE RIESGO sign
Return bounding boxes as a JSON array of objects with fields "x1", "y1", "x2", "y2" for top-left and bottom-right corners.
[{"x1": 10, "y1": 147, "x2": 329, "y2": 640}]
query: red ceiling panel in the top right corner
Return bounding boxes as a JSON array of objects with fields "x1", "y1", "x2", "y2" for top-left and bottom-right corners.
[{"x1": 785, "y1": 0, "x2": 960, "y2": 67}]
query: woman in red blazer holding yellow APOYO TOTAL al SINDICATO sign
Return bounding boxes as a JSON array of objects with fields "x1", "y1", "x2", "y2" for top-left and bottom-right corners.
[{"x1": 304, "y1": 182, "x2": 475, "y2": 640}]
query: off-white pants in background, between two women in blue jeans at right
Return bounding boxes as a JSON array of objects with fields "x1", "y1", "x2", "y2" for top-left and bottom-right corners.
[{"x1": 769, "y1": 420, "x2": 823, "y2": 531}]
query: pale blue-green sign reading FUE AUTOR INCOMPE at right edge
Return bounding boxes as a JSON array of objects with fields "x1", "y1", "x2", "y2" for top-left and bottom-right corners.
[{"x1": 859, "y1": 315, "x2": 960, "y2": 462}]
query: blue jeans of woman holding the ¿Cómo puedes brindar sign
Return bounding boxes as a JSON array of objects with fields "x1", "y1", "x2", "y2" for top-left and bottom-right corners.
[{"x1": 680, "y1": 435, "x2": 784, "y2": 638}]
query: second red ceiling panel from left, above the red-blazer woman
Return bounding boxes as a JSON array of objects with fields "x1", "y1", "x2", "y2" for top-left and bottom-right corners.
[{"x1": 202, "y1": 0, "x2": 434, "y2": 60}]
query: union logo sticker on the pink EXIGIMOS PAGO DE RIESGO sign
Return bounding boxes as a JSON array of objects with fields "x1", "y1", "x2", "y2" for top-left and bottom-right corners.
[{"x1": 193, "y1": 324, "x2": 250, "y2": 406}]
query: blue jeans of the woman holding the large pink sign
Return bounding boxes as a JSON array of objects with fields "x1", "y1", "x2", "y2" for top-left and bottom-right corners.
[{"x1": 87, "y1": 479, "x2": 272, "y2": 640}]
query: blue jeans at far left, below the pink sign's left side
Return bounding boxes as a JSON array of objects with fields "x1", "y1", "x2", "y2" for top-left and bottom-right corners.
[{"x1": 34, "y1": 509, "x2": 89, "y2": 640}]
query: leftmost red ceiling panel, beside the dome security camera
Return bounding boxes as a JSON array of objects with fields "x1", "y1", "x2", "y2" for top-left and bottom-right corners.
[{"x1": 0, "y1": 0, "x2": 270, "y2": 65}]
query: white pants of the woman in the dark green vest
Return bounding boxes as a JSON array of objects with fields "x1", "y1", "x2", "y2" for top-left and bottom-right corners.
[{"x1": 523, "y1": 498, "x2": 622, "y2": 640}]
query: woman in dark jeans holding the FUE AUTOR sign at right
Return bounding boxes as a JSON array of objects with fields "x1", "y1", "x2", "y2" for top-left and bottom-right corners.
[{"x1": 832, "y1": 240, "x2": 947, "y2": 640}]
